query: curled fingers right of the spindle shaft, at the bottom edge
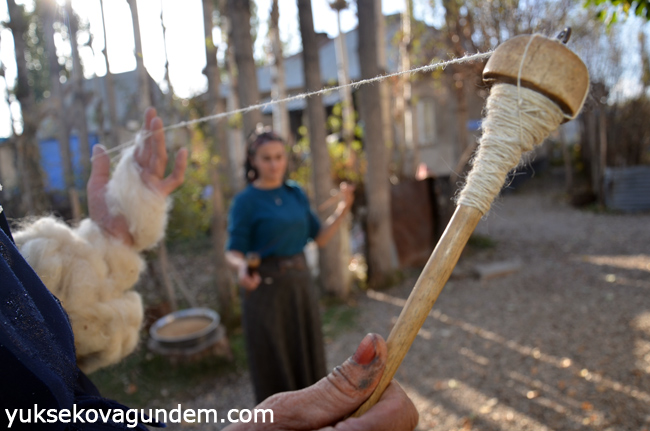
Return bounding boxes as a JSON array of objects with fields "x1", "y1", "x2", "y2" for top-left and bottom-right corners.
[{"x1": 321, "y1": 380, "x2": 419, "y2": 431}]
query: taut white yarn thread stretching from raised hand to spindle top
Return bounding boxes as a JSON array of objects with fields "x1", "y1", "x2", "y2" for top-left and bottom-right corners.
[{"x1": 98, "y1": 51, "x2": 494, "y2": 160}]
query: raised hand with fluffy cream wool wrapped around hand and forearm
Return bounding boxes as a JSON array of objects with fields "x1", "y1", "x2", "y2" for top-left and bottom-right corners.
[{"x1": 14, "y1": 109, "x2": 187, "y2": 373}]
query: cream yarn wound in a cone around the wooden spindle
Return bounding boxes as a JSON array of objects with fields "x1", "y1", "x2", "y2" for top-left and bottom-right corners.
[{"x1": 458, "y1": 84, "x2": 564, "y2": 214}]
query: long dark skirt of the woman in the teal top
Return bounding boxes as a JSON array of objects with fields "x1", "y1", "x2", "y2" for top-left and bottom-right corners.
[{"x1": 243, "y1": 255, "x2": 326, "y2": 403}]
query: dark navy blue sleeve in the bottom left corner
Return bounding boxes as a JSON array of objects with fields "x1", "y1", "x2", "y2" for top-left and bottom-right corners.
[{"x1": 0, "y1": 212, "x2": 158, "y2": 431}]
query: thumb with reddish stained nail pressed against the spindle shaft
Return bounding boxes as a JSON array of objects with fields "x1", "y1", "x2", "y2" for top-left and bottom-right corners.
[{"x1": 260, "y1": 334, "x2": 386, "y2": 430}]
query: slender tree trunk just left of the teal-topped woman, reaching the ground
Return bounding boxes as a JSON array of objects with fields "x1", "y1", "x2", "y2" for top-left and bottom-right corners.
[{"x1": 203, "y1": 0, "x2": 235, "y2": 322}]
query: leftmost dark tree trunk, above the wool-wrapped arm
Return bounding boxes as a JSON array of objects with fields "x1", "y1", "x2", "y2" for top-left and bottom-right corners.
[{"x1": 7, "y1": 0, "x2": 47, "y2": 215}]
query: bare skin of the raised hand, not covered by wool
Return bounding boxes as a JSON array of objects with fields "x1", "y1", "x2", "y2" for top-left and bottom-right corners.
[{"x1": 87, "y1": 108, "x2": 187, "y2": 245}]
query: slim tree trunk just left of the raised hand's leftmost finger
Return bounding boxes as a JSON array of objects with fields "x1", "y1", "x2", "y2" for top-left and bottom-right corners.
[{"x1": 65, "y1": 0, "x2": 90, "y2": 184}]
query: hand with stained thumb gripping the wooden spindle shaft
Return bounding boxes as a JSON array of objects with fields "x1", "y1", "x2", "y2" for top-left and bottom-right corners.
[{"x1": 226, "y1": 334, "x2": 418, "y2": 431}]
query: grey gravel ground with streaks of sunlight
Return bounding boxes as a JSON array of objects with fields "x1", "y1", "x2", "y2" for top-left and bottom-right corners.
[{"x1": 161, "y1": 183, "x2": 650, "y2": 431}]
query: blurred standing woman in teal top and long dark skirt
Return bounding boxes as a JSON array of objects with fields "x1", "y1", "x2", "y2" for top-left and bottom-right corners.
[{"x1": 226, "y1": 132, "x2": 354, "y2": 402}]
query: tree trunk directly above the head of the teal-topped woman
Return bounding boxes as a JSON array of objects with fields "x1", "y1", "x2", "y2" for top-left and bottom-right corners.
[{"x1": 228, "y1": 0, "x2": 262, "y2": 136}]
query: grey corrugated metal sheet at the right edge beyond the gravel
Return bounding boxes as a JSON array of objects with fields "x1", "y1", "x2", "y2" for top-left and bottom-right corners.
[{"x1": 604, "y1": 166, "x2": 650, "y2": 212}]
